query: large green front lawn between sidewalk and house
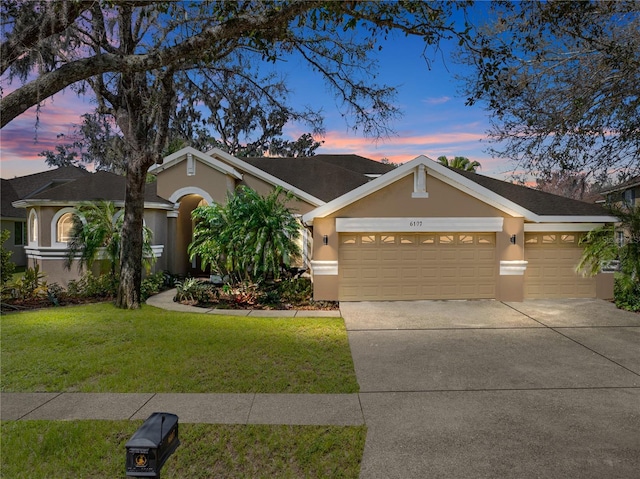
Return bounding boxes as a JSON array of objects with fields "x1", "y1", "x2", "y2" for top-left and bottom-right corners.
[{"x1": 0, "y1": 304, "x2": 358, "y2": 393}]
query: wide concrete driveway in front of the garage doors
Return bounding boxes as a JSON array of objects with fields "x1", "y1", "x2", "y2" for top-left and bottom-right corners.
[{"x1": 341, "y1": 300, "x2": 640, "y2": 479}]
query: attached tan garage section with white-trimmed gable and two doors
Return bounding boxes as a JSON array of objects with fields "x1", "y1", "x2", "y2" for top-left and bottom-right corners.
[{"x1": 303, "y1": 157, "x2": 616, "y2": 301}]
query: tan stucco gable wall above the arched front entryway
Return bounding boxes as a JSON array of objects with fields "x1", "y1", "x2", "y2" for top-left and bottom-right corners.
[{"x1": 157, "y1": 161, "x2": 229, "y2": 203}]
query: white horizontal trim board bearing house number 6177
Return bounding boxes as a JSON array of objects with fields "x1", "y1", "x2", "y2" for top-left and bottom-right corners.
[{"x1": 336, "y1": 216, "x2": 504, "y2": 233}]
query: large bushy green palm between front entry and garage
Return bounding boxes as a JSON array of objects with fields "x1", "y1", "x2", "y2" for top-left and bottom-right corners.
[{"x1": 189, "y1": 186, "x2": 300, "y2": 282}]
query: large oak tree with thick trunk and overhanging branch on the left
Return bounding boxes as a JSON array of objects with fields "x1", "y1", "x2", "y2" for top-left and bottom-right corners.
[{"x1": 0, "y1": 0, "x2": 476, "y2": 308}]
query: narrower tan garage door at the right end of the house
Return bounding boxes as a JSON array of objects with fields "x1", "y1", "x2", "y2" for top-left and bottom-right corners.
[{"x1": 524, "y1": 233, "x2": 596, "y2": 299}]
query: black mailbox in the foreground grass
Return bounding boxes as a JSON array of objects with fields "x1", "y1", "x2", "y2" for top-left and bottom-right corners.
[{"x1": 125, "y1": 412, "x2": 180, "y2": 478}]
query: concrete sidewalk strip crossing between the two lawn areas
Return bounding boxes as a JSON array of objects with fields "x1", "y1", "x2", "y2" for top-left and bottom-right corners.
[{"x1": 0, "y1": 393, "x2": 364, "y2": 426}]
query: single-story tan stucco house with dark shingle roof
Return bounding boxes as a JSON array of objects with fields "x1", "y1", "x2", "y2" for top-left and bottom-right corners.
[{"x1": 3, "y1": 147, "x2": 616, "y2": 301}]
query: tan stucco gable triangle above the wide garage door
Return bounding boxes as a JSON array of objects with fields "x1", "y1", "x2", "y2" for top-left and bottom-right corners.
[{"x1": 330, "y1": 175, "x2": 508, "y2": 218}]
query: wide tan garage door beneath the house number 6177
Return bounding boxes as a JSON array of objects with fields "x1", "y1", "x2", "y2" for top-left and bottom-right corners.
[{"x1": 338, "y1": 233, "x2": 497, "y2": 301}]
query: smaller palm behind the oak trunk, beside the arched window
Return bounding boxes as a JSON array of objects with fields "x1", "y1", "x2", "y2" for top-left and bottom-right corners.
[{"x1": 65, "y1": 200, "x2": 155, "y2": 277}]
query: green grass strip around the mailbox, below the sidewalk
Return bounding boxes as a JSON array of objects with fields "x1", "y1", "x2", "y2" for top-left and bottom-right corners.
[{"x1": 0, "y1": 421, "x2": 366, "y2": 479}]
